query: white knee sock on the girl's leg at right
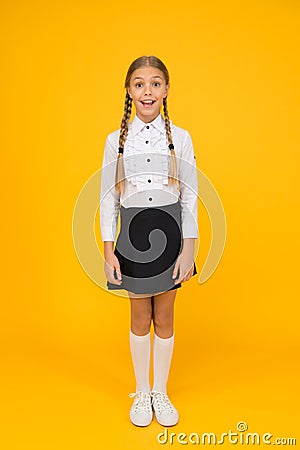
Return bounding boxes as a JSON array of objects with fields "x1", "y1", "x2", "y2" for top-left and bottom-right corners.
[{"x1": 153, "y1": 333, "x2": 174, "y2": 393}]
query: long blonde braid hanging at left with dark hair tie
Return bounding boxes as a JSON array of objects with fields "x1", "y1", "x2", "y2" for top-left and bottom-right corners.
[{"x1": 115, "y1": 92, "x2": 132, "y2": 194}]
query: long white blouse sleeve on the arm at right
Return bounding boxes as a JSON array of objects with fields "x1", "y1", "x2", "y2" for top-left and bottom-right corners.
[{"x1": 178, "y1": 131, "x2": 198, "y2": 238}]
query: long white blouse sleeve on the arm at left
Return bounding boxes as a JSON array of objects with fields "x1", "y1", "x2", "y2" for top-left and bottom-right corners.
[{"x1": 100, "y1": 135, "x2": 120, "y2": 242}]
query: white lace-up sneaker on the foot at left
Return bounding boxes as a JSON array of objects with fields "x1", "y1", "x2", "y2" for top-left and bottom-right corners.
[{"x1": 129, "y1": 391, "x2": 153, "y2": 427}]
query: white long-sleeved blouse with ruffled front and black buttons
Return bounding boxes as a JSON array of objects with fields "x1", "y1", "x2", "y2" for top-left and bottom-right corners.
[{"x1": 100, "y1": 114, "x2": 198, "y2": 241}]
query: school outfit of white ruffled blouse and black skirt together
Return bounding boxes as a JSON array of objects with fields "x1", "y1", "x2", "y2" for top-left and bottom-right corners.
[{"x1": 100, "y1": 114, "x2": 198, "y2": 294}]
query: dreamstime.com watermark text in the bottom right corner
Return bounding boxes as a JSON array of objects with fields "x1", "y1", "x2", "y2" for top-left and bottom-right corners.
[{"x1": 157, "y1": 421, "x2": 296, "y2": 445}]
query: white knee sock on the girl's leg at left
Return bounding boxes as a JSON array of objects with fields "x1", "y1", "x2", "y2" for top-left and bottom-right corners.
[{"x1": 130, "y1": 330, "x2": 150, "y2": 392}]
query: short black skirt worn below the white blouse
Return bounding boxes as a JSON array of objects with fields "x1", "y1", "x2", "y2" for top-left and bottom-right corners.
[{"x1": 107, "y1": 201, "x2": 197, "y2": 295}]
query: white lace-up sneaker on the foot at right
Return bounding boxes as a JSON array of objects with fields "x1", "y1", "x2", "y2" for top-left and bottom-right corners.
[{"x1": 150, "y1": 391, "x2": 178, "y2": 427}]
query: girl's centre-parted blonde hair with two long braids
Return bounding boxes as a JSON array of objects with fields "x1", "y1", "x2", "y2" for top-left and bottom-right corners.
[{"x1": 115, "y1": 56, "x2": 178, "y2": 194}]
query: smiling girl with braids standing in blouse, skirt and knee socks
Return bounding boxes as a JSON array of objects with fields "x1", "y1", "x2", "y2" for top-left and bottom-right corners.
[{"x1": 100, "y1": 56, "x2": 198, "y2": 426}]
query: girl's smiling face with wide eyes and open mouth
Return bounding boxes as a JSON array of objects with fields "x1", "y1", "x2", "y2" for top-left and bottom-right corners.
[{"x1": 127, "y1": 66, "x2": 170, "y2": 123}]
